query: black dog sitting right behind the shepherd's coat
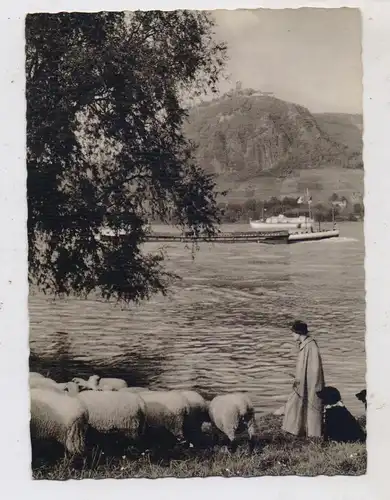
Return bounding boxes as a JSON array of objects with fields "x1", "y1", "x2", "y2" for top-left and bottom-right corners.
[{"x1": 317, "y1": 386, "x2": 366, "y2": 443}]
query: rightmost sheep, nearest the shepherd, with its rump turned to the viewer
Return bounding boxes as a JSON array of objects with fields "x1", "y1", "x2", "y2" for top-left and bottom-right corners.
[{"x1": 209, "y1": 393, "x2": 256, "y2": 451}]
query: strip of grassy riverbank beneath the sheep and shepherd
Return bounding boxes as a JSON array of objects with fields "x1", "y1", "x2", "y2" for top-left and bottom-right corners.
[{"x1": 33, "y1": 415, "x2": 367, "y2": 480}]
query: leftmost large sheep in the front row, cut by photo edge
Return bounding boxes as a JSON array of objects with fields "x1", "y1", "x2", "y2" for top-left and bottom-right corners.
[{"x1": 30, "y1": 388, "x2": 88, "y2": 455}]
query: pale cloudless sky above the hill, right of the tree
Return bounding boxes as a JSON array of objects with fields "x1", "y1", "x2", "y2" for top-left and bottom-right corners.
[{"x1": 207, "y1": 8, "x2": 363, "y2": 113}]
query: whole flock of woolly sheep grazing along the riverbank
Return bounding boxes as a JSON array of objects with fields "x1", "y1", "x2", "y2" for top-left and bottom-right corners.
[{"x1": 29, "y1": 372, "x2": 256, "y2": 455}]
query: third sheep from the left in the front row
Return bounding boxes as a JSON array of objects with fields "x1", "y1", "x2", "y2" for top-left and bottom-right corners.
[{"x1": 137, "y1": 390, "x2": 190, "y2": 442}]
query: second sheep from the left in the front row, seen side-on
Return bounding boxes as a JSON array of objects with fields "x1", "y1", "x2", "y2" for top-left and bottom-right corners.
[{"x1": 77, "y1": 391, "x2": 145, "y2": 440}]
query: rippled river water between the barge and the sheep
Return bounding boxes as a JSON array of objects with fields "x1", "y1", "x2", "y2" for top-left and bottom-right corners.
[{"x1": 30, "y1": 223, "x2": 365, "y2": 414}]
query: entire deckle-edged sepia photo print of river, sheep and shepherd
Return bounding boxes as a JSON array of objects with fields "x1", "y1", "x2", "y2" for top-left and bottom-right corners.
[{"x1": 25, "y1": 8, "x2": 370, "y2": 480}]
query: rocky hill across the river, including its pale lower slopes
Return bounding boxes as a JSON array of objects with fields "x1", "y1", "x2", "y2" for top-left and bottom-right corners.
[{"x1": 185, "y1": 89, "x2": 363, "y2": 202}]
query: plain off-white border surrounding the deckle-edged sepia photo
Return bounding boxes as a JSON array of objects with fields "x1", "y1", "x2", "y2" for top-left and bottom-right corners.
[{"x1": 0, "y1": 0, "x2": 390, "y2": 500}]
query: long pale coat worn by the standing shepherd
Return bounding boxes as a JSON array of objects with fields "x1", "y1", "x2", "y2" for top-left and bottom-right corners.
[{"x1": 282, "y1": 337, "x2": 325, "y2": 437}]
